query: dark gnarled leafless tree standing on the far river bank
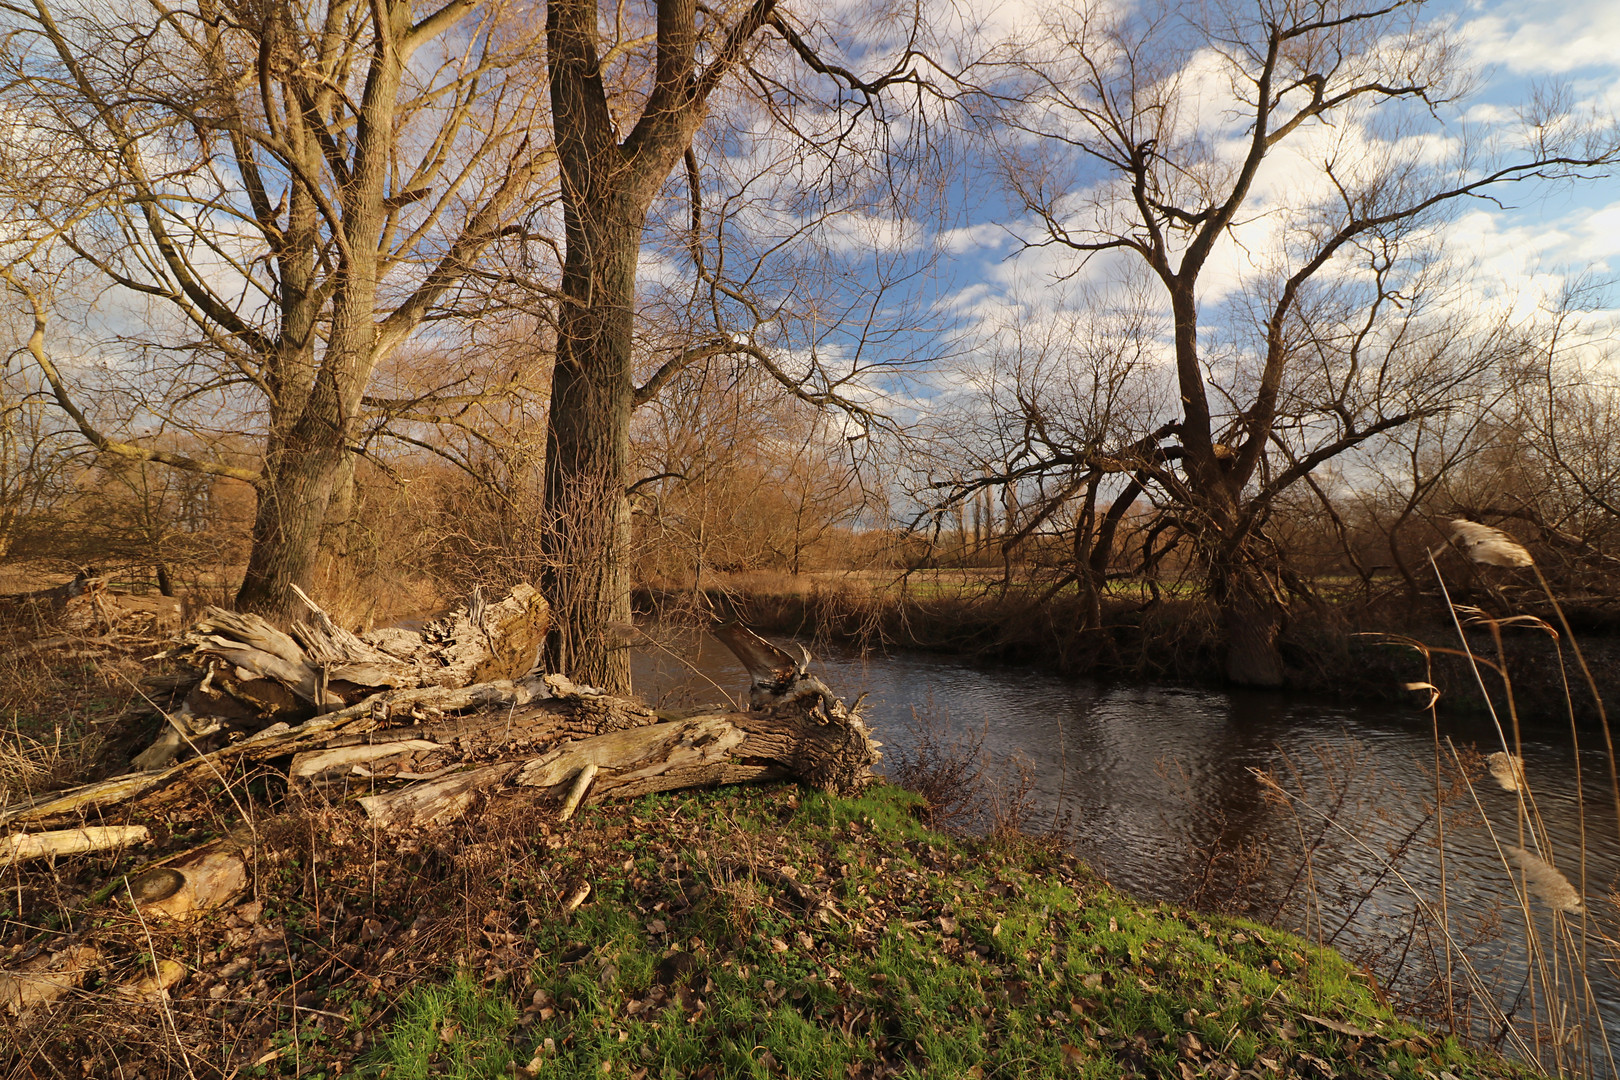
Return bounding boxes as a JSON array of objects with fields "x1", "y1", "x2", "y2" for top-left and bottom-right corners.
[{"x1": 978, "y1": 0, "x2": 1617, "y2": 685}]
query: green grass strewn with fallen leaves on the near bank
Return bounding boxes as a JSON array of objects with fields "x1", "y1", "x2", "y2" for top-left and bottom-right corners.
[{"x1": 348, "y1": 787, "x2": 1528, "y2": 1080}]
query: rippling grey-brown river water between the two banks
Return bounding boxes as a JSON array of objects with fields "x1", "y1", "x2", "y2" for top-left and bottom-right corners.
[{"x1": 635, "y1": 635, "x2": 1620, "y2": 1075}]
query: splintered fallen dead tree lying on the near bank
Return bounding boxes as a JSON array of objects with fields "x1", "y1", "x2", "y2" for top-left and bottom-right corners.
[{"x1": 0, "y1": 586, "x2": 878, "y2": 853}]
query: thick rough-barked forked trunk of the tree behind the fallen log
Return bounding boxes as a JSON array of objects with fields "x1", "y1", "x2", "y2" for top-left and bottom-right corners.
[{"x1": 543, "y1": 0, "x2": 774, "y2": 693}]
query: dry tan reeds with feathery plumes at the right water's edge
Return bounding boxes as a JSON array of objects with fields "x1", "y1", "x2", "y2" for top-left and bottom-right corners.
[{"x1": 1259, "y1": 544, "x2": 1620, "y2": 1077}]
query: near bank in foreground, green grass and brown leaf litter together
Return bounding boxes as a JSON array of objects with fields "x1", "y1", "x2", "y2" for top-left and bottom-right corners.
[{"x1": 12, "y1": 785, "x2": 1548, "y2": 1080}]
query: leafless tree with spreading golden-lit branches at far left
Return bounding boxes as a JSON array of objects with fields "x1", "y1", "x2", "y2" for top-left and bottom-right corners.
[{"x1": 0, "y1": 0, "x2": 556, "y2": 614}]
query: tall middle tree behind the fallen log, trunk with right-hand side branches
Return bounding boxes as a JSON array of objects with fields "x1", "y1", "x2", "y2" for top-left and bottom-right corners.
[{"x1": 546, "y1": 0, "x2": 917, "y2": 690}]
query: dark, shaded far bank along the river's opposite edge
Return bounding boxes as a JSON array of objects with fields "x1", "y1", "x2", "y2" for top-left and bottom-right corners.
[{"x1": 635, "y1": 575, "x2": 1620, "y2": 722}]
